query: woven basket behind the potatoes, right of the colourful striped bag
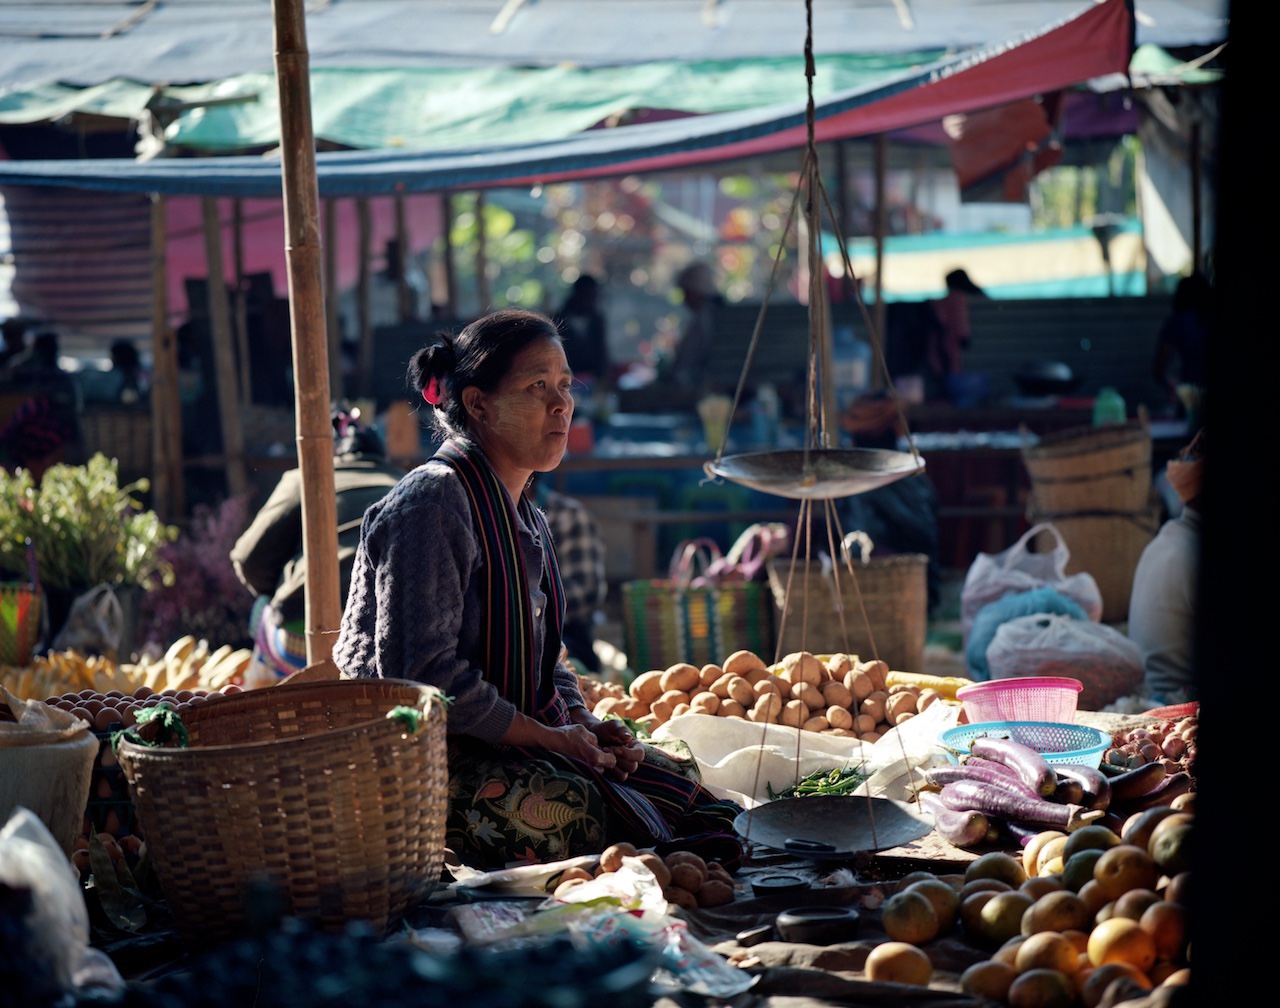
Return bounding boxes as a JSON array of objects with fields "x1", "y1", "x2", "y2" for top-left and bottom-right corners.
[{"x1": 768, "y1": 532, "x2": 929, "y2": 672}]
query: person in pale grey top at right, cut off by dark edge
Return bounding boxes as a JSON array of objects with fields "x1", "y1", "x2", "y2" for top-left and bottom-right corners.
[{"x1": 1129, "y1": 430, "x2": 1204, "y2": 704}]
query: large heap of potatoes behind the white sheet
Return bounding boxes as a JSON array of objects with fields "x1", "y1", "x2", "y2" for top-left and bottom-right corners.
[{"x1": 584, "y1": 650, "x2": 942, "y2": 742}]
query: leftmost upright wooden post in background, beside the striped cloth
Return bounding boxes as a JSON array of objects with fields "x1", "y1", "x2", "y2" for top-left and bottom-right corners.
[{"x1": 151, "y1": 193, "x2": 186, "y2": 522}]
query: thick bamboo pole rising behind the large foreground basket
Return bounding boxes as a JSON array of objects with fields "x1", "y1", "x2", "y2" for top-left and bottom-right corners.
[{"x1": 271, "y1": 0, "x2": 342, "y2": 665}]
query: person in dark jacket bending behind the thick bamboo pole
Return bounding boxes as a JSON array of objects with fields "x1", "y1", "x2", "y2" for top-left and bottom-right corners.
[{"x1": 230, "y1": 409, "x2": 404, "y2": 678}]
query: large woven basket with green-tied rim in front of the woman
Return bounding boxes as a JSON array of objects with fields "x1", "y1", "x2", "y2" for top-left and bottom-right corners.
[{"x1": 118, "y1": 679, "x2": 448, "y2": 943}]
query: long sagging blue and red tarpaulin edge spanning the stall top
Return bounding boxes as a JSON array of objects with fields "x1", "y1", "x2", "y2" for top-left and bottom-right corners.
[{"x1": 0, "y1": 0, "x2": 1134, "y2": 197}]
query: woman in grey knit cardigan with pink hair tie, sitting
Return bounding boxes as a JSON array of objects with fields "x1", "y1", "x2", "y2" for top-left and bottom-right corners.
[{"x1": 333, "y1": 308, "x2": 741, "y2": 870}]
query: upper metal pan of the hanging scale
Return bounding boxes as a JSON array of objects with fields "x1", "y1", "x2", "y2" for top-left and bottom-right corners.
[{"x1": 703, "y1": 448, "x2": 924, "y2": 500}]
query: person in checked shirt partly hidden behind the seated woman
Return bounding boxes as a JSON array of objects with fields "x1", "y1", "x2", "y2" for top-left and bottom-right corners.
[{"x1": 532, "y1": 480, "x2": 609, "y2": 673}]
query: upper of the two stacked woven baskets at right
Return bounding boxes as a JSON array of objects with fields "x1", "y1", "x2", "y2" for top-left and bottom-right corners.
[{"x1": 1023, "y1": 420, "x2": 1151, "y2": 521}]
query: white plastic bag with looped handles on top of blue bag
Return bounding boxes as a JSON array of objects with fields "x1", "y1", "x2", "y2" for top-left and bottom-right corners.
[{"x1": 960, "y1": 522, "x2": 1102, "y2": 642}]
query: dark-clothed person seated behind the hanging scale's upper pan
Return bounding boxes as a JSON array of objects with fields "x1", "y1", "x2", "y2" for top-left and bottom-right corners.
[{"x1": 840, "y1": 394, "x2": 942, "y2": 613}]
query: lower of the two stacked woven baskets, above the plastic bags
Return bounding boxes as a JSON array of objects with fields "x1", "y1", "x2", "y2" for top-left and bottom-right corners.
[{"x1": 1030, "y1": 504, "x2": 1160, "y2": 623}]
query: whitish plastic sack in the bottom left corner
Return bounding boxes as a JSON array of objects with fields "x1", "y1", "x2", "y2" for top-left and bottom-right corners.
[{"x1": 0, "y1": 807, "x2": 124, "y2": 1004}]
